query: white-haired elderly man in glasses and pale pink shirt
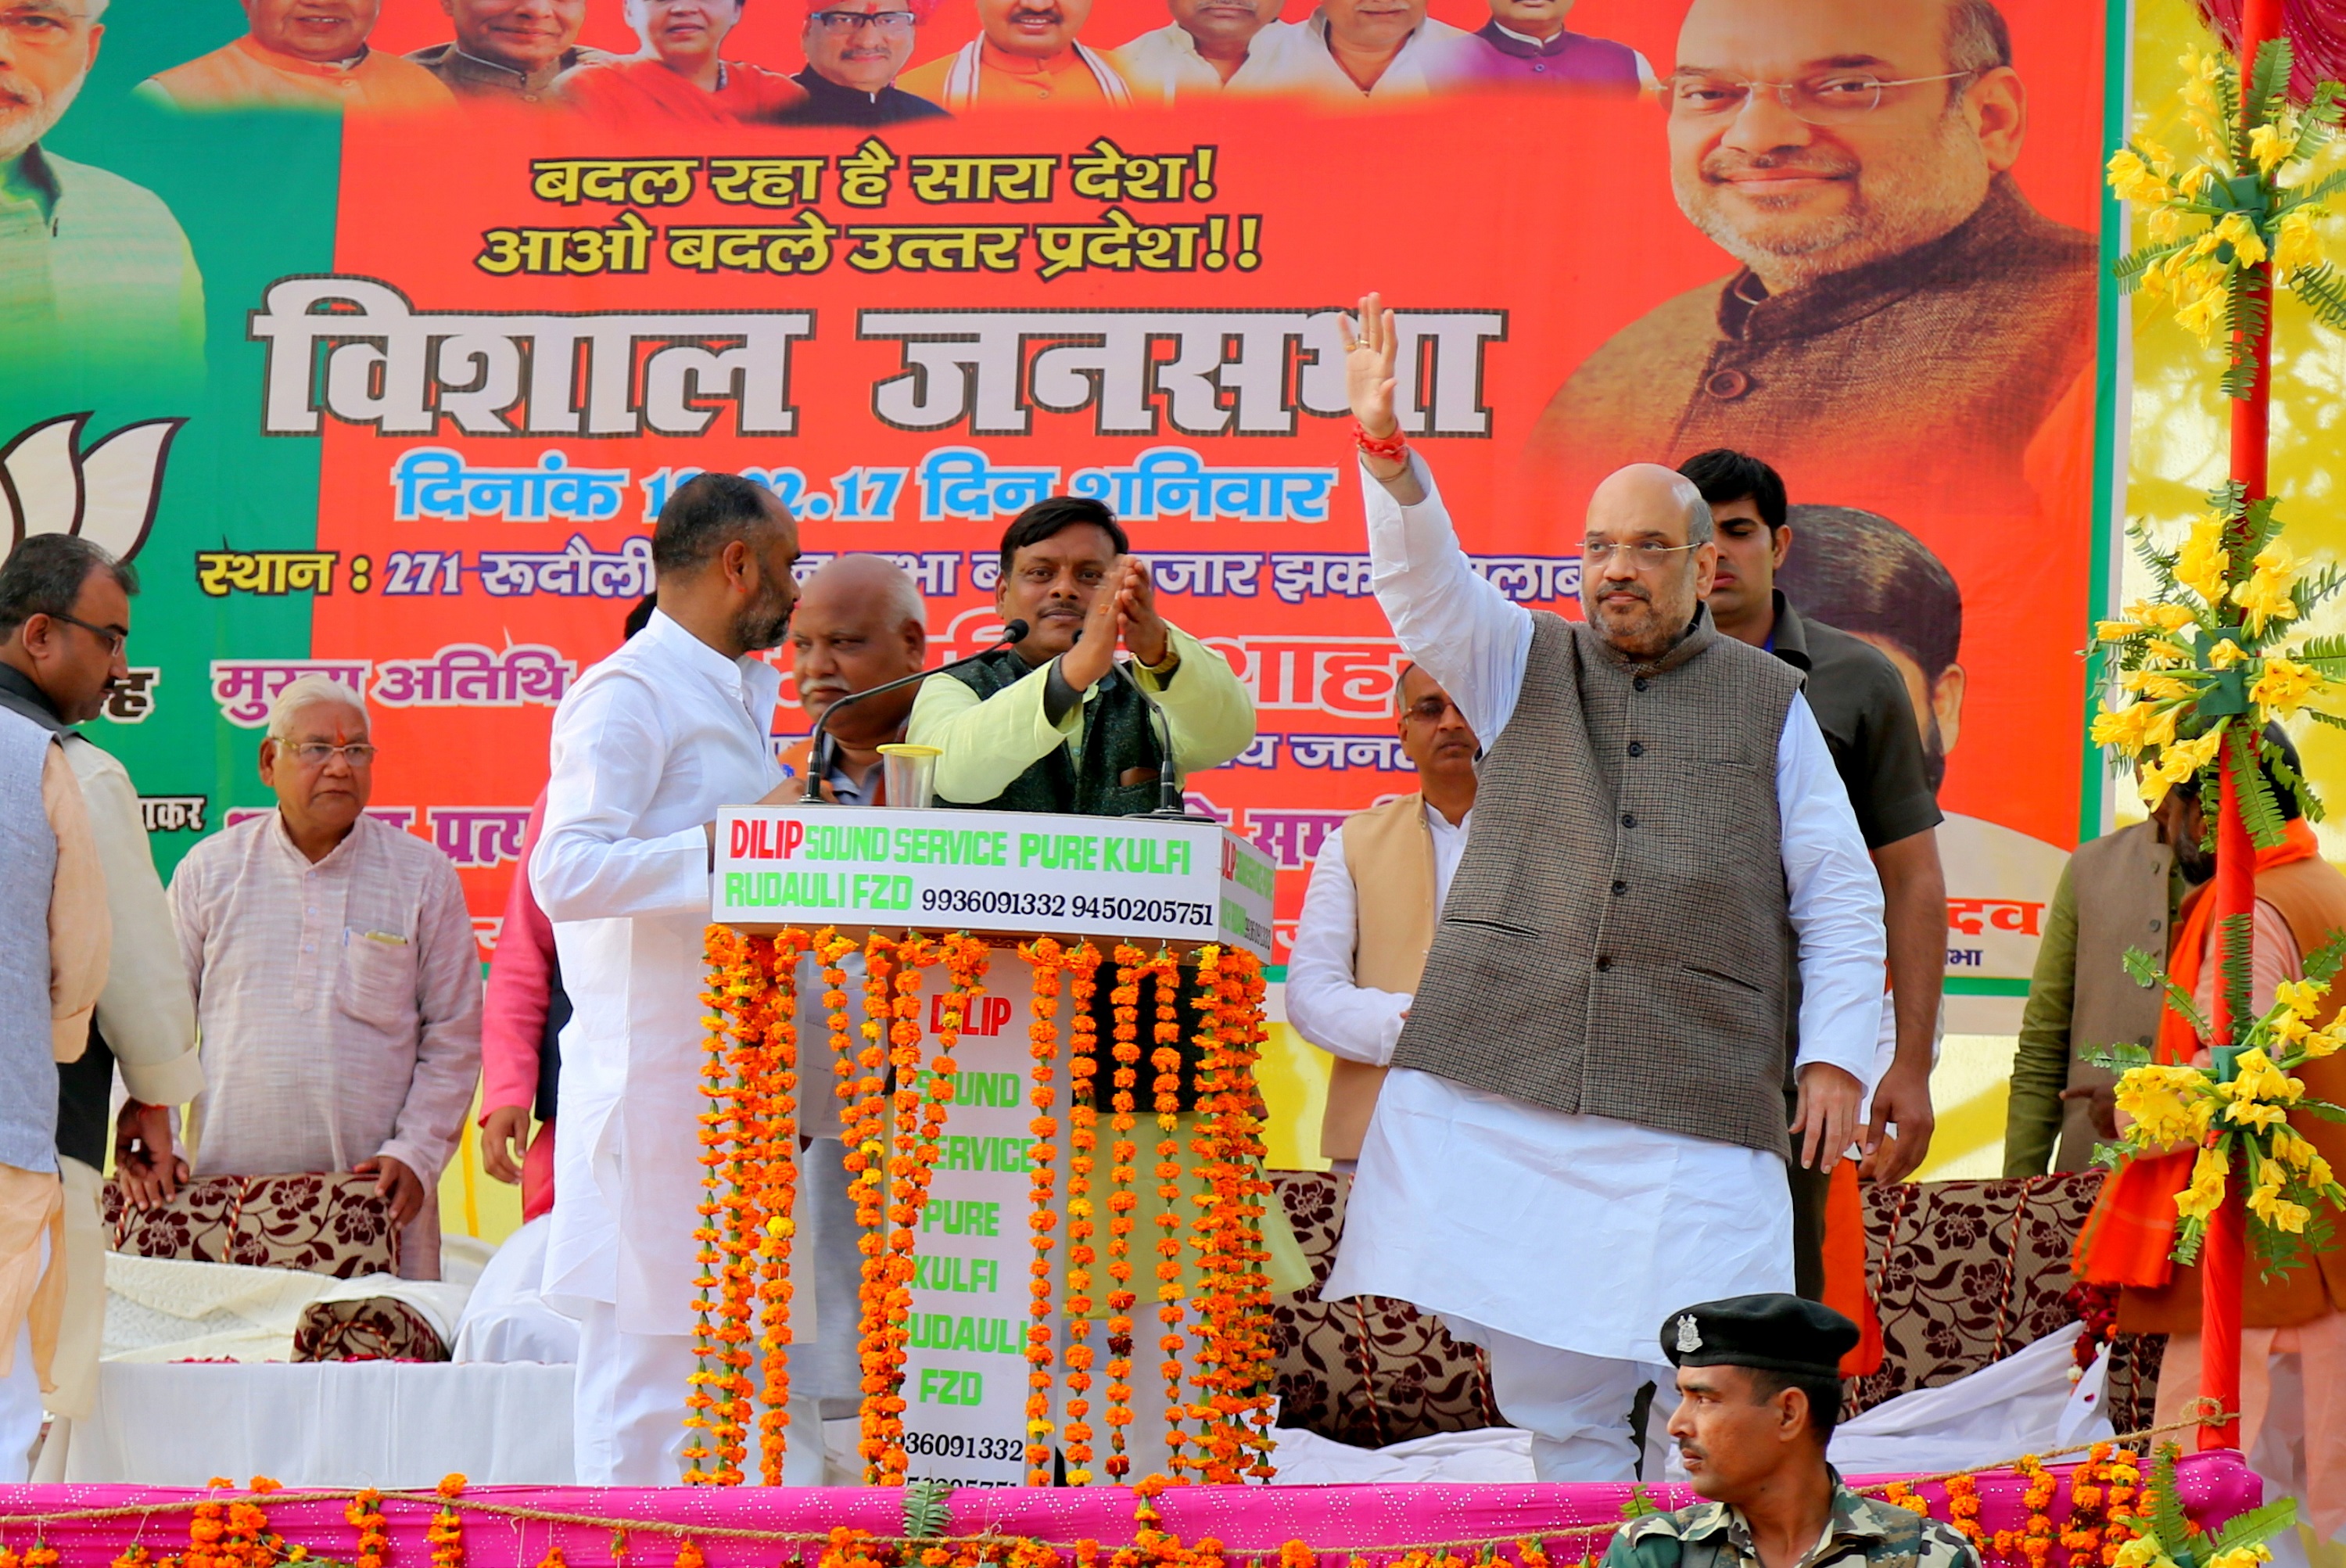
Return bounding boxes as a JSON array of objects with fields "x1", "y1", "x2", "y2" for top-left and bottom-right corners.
[{"x1": 171, "y1": 673, "x2": 481, "y2": 1279}]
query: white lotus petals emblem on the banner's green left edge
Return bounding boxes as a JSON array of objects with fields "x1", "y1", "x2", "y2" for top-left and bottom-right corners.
[{"x1": 0, "y1": 413, "x2": 188, "y2": 561}]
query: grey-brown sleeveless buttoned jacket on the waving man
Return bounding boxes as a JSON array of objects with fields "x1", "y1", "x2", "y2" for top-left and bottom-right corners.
[{"x1": 1394, "y1": 610, "x2": 1799, "y2": 1155}]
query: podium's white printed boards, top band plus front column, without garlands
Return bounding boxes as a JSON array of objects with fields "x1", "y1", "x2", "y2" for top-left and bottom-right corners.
[{"x1": 708, "y1": 806, "x2": 1272, "y2": 1486}]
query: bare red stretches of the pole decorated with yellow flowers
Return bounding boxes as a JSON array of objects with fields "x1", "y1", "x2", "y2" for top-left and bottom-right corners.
[{"x1": 2198, "y1": 0, "x2": 2280, "y2": 1448}]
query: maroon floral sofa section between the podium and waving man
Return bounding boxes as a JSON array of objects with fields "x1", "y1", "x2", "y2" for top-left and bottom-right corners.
[{"x1": 1269, "y1": 1172, "x2": 1504, "y2": 1448}]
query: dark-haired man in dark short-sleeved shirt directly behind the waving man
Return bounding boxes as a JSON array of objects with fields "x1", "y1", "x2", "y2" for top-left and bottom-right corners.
[{"x1": 1677, "y1": 448, "x2": 1947, "y2": 1301}]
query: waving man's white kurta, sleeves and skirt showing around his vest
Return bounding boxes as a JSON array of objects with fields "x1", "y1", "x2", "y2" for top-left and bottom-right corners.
[{"x1": 1321, "y1": 457, "x2": 1884, "y2": 1362}]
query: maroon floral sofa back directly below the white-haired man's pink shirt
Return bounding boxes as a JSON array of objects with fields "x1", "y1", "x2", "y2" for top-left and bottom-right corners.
[{"x1": 106, "y1": 1172, "x2": 399, "y2": 1279}]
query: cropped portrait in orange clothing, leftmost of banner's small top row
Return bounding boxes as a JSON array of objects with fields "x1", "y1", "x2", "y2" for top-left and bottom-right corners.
[{"x1": 138, "y1": 0, "x2": 455, "y2": 115}]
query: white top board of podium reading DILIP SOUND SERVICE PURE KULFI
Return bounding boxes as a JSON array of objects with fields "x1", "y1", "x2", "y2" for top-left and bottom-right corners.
[{"x1": 708, "y1": 806, "x2": 1274, "y2": 960}]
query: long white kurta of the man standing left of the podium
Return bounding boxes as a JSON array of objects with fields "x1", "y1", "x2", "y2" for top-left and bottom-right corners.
[{"x1": 530, "y1": 610, "x2": 784, "y2": 1333}]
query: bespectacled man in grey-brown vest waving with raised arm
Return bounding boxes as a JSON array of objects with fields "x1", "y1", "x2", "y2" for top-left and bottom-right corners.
[{"x1": 1321, "y1": 293, "x2": 1884, "y2": 1481}]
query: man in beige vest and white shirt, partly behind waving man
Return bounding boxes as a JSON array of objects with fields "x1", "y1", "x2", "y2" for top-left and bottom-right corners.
[{"x1": 1288, "y1": 664, "x2": 1483, "y2": 1169}]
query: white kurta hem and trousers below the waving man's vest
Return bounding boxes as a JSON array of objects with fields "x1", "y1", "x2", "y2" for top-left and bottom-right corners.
[{"x1": 1321, "y1": 1068, "x2": 1792, "y2": 1481}]
